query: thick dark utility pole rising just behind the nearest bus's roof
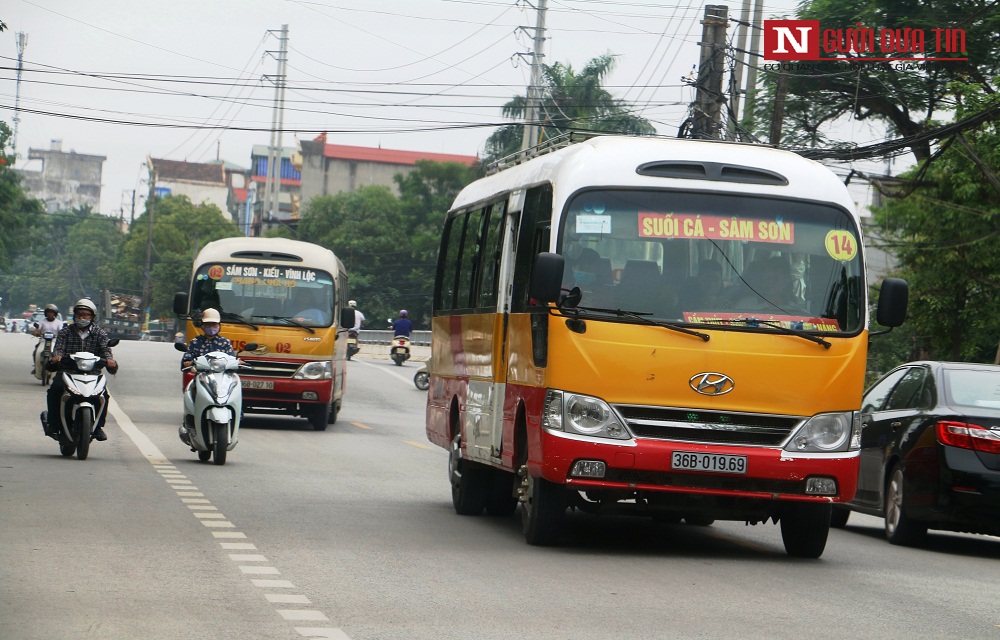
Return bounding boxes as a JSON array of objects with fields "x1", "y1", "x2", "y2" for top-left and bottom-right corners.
[{"x1": 692, "y1": 4, "x2": 729, "y2": 138}]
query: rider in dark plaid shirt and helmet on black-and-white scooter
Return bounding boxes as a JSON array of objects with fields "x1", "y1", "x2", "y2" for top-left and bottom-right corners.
[{"x1": 42, "y1": 298, "x2": 118, "y2": 442}]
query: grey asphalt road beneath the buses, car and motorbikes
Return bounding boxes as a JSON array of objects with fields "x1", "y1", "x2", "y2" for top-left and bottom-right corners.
[{"x1": 0, "y1": 334, "x2": 1000, "y2": 640}]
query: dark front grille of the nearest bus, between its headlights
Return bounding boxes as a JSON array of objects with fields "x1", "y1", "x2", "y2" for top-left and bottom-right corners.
[{"x1": 615, "y1": 405, "x2": 803, "y2": 447}]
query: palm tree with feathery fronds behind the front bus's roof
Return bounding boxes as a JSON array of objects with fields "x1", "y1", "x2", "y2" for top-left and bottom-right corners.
[{"x1": 485, "y1": 53, "x2": 656, "y2": 162}]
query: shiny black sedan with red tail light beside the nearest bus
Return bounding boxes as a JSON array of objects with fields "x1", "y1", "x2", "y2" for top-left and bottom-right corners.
[{"x1": 832, "y1": 362, "x2": 1000, "y2": 544}]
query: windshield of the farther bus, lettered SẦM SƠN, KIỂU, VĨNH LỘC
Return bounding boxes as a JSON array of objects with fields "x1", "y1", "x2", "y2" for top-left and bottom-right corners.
[{"x1": 191, "y1": 263, "x2": 334, "y2": 328}]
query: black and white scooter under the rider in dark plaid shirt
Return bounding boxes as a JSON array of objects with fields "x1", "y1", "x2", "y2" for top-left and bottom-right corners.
[{"x1": 41, "y1": 338, "x2": 118, "y2": 460}]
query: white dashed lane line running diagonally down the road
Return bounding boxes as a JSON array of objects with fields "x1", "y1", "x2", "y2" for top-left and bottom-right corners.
[{"x1": 108, "y1": 397, "x2": 351, "y2": 640}]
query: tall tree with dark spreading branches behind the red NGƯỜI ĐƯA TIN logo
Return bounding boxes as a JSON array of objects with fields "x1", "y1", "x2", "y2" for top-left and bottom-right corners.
[{"x1": 754, "y1": 0, "x2": 1000, "y2": 161}]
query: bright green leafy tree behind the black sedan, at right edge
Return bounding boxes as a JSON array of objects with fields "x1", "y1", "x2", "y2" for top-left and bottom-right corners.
[{"x1": 874, "y1": 86, "x2": 1000, "y2": 362}]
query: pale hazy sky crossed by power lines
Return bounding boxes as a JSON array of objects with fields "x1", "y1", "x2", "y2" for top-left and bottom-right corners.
[{"x1": 0, "y1": 0, "x2": 794, "y2": 216}]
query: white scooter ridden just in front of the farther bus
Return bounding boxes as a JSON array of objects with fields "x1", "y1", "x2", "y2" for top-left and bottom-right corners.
[{"x1": 174, "y1": 342, "x2": 257, "y2": 465}]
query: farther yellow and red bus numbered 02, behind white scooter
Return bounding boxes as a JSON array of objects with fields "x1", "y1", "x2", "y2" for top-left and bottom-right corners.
[{"x1": 174, "y1": 238, "x2": 354, "y2": 431}]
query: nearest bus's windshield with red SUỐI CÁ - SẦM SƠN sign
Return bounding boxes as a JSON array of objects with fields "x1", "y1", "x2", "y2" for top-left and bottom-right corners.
[{"x1": 559, "y1": 190, "x2": 864, "y2": 333}]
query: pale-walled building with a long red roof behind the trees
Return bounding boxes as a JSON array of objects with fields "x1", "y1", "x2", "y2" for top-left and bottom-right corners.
[{"x1": 299, "y1": 136, "x2": 479, "y2": 210}]
